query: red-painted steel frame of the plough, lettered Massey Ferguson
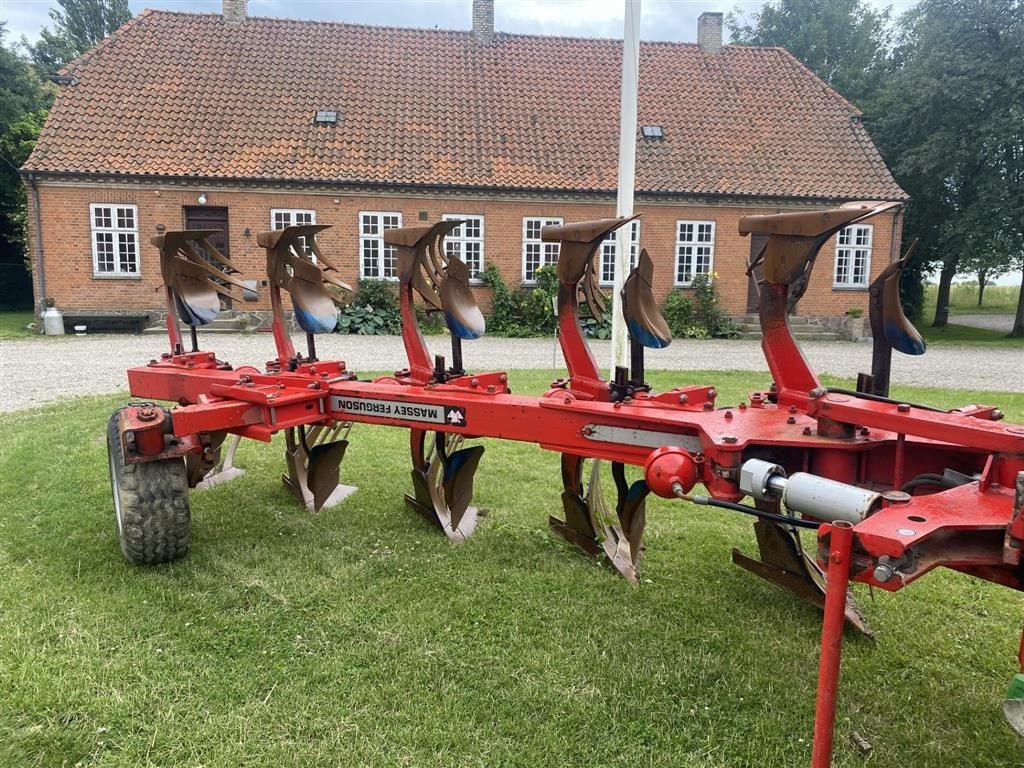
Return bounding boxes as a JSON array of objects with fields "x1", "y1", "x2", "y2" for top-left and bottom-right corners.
[{"x1": 117, "y1": 219, "x2": 1024, "y2": 768}]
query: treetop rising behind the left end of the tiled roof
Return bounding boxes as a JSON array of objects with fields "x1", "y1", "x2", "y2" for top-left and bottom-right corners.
[{"x1": 28, "y1": 0, "x2": 131, "y2": 75}]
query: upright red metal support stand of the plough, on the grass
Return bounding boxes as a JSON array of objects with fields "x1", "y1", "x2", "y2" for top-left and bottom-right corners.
[{"x1": 811, "y1": 520, "x2": 853, "y2": 768}]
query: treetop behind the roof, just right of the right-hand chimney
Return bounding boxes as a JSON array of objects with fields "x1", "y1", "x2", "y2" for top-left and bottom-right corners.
[{"x1": 726, "y1": 0, "x2": 889, "y2": 105}]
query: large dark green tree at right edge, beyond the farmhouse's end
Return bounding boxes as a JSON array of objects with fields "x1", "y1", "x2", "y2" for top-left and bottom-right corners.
[{"x1": 868, "y1": 0, "x2": 1024, "y2": 327}]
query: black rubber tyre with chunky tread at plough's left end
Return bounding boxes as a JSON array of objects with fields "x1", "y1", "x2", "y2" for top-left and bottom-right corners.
[{"x1": 106, "y1": 409, "x2": 191, "y2": 565}]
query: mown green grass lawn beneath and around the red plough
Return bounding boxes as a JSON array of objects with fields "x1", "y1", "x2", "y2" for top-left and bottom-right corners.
[{"x1": 0, "y1": 372, "x2": 1024, "y2": 768}]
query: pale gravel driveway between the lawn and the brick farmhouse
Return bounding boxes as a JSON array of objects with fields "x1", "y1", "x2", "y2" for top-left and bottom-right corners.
[{"x1": 0, "y1": 334, "x2": 1024, "y2": 411}]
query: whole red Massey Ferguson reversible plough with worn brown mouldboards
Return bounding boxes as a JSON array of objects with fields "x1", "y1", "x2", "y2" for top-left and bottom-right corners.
[{"x1": 108, "y1": 203, "x2": 1024, "y2": 768}]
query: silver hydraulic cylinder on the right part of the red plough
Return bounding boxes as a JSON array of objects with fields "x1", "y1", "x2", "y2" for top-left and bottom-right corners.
[{"x1": 739, "y1": 459, "x2": 882, "y2": 524}]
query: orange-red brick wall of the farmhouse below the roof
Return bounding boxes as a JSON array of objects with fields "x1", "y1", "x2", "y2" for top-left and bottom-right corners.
[{"x1": 30, "y1": 182, "x2": 899, "y2": 315}]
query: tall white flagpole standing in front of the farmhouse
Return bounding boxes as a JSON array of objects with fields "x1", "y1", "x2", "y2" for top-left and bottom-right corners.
[{"x1": 610, "y1": 0, "x2": 640, "y2": 377}]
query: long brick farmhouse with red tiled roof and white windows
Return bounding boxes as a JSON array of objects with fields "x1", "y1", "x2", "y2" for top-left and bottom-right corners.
[{"x1": 23, "y1": 0, "x2": 905, "y2": 327}]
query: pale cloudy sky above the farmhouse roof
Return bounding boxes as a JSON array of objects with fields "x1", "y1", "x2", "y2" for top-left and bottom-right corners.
[{"x1": 0, "y1": 0, "x2": 913, "y2": 43}]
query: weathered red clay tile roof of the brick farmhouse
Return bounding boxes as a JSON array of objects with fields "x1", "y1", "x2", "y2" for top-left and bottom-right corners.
[{"x1": 25, "y1": 11, "x2": 905, "y2": 199}]
